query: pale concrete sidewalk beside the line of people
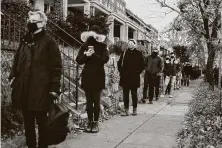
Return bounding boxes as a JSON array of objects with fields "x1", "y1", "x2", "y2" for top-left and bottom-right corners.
[{"x1": 51, "y1": 79, "x2": 201, "y2": 148}]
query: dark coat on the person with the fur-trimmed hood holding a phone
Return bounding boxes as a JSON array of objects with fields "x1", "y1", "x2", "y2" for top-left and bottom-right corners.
[{"x1": 76, "y1": 42, "x2": 109, "y2": 91}]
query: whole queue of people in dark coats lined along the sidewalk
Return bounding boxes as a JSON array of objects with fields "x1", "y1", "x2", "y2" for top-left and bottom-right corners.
[{"x1": 9, "y1": 11, "x2": 203, "y2": 148}]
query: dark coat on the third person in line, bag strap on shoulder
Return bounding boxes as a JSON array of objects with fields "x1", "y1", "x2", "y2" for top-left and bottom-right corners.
[{"x1": 117, "y1": 49, "x2": 145, "y2": 88}]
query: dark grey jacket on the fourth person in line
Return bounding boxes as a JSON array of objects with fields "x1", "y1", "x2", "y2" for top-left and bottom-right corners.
[{"x1": 145, "y1": 55, "x2": 164, "y2": 76}]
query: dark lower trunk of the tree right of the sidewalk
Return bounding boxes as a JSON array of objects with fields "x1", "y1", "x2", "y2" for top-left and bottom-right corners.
[{"x1": 206, "y1": 41, "x2": 216, "y2": 90}]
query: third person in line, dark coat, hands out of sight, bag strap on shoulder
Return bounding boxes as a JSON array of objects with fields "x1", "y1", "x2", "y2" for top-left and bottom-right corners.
[{"x1": 117, "y1": 39, "x2": 145, "y2": 116}]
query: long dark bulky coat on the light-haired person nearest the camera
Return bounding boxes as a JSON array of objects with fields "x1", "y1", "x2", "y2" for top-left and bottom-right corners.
[{"x1": 9, "y1": 31, "x2": 62, "y2": 111}]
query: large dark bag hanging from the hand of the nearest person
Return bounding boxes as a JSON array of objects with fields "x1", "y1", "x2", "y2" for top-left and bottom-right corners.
[{"x1": 47, "y1": 103, "x2": 69, "y2": 145}]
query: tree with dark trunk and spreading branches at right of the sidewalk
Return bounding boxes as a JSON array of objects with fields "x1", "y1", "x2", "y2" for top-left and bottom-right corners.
[{"x1": 156, "y1": 0, "x2": 222, "y2": 89}]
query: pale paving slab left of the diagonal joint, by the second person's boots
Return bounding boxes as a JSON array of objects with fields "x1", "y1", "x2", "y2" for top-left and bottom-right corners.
[{"x1": 54, "y1": 113, "x2": 153, "y2": 148}]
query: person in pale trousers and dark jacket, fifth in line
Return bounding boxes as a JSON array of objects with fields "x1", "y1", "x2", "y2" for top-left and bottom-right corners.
[{"x1": 161, "y1": 53, "x2": 179, "y2": 98}]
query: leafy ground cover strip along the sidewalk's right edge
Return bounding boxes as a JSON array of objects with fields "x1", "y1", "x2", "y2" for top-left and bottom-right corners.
[{"x1": 177, "y1": 83, "x2": 222, "y2": 148}]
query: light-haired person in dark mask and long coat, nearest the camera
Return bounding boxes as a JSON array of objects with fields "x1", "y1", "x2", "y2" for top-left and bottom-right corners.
[{"x1": 9, "y1": 11, "x2": 62, "y2": 148}]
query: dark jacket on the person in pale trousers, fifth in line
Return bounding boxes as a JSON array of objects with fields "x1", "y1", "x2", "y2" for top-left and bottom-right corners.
[{"x1": 163, "y1": 59, "x2": 180, "y2": 76}]
